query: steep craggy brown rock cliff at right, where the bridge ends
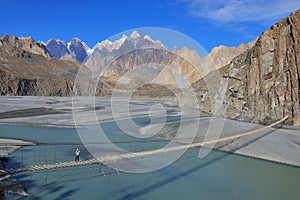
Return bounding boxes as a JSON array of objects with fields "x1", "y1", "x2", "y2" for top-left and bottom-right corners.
[{"x1": 194, "y1": 10, "x2": 300, "y2": 125}]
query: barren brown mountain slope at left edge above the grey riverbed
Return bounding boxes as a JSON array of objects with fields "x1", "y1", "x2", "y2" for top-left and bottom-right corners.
[{"x1": 0, "y1": 38, "x2": 106, "y2": 96}]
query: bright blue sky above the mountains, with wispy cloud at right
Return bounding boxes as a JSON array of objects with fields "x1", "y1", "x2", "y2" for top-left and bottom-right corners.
[{"x1": 0, "y1": 0, "x2": 300, "y2": 51}]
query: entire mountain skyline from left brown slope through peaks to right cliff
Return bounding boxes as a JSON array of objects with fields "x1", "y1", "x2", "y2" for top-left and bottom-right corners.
[{"x1": 0, "y1": 10, "x2": 300, "y2": 125}]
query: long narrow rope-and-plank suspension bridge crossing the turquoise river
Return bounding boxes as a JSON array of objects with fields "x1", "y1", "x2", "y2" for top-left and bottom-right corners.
[{"x1": 0, "y1": 116, "x2": 288, "y2": 174}]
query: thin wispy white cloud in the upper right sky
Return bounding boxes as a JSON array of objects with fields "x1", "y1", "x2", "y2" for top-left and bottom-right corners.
[{"x1": 184, "y1": 0, "x2": 300, "y2": 24}]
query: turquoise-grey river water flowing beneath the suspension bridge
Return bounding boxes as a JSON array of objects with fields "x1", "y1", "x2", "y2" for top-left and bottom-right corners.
[{"x1": 0, "y1": 117, "x2": 300, "y2": 199}]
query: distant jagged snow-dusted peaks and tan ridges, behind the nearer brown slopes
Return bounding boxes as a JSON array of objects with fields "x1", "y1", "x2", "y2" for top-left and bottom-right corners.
[{"x1": 42, "y1": 31, "x2": 254, "y2": 87}]
